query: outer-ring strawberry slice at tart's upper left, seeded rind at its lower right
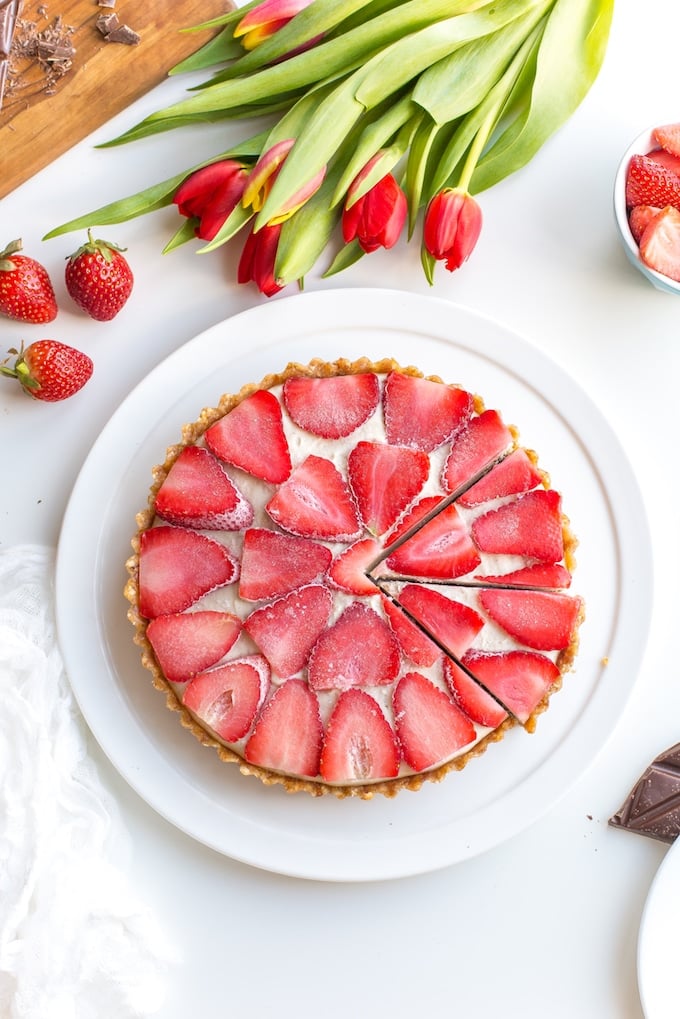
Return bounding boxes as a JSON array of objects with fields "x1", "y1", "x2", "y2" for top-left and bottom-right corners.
[{"x1": 156, "y1": 446, "x2": 253, "y2": 531}]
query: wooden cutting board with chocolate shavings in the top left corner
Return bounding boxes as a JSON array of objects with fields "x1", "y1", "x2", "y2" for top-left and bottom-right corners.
[{"x1": 0, "y1": 0, "x2": 233, "y2": 198}]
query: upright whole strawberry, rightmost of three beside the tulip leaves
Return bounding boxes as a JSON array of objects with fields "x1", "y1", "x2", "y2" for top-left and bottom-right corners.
[{"x1": 65, "y1": 230, "x2": 135, "y2": 322}]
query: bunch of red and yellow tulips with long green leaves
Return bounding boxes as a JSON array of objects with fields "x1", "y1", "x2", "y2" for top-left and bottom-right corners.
[{"x1": 47, "y1": 0, "x2": 614, "y2": 296}]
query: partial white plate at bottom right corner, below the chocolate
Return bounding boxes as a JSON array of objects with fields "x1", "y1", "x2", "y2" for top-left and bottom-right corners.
[{"x1": 637, "y1": 840, "x2": 680, "y2": 1019}]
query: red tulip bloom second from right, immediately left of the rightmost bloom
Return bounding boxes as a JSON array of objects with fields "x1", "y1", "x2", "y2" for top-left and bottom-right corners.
[{"x1": 343, "y1": 153, "x2": 408, "y2": 254}]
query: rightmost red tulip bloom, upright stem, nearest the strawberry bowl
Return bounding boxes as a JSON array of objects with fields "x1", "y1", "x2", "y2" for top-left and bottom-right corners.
[{"x1": 423, "y1": 187, "x2": 481, "y2": 272}]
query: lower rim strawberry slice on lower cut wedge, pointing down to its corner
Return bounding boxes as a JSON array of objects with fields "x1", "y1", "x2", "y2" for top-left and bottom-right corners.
[{"x1": 459, "y1": 651, "x2": 560, "y2": 722}]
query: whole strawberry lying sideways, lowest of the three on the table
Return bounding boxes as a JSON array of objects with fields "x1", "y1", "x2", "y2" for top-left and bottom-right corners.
[{"x1": 0, "y1": 339, "x2": 94, "y2": 403}]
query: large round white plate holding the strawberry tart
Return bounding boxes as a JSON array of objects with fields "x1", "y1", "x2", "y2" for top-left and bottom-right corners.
[{"x1": 56, "y1": 289, "x2": 651, "y2": 880}]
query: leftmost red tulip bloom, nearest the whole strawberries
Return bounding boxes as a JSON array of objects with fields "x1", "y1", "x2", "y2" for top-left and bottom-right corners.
[{"x1": 172, "y1": 159, "x2": 248, "y2": 240}]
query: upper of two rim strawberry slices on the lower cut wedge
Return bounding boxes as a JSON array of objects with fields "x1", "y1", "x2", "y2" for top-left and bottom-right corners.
[{"x1": 479, "y1": 588, "x2": 582, "y2": 651}]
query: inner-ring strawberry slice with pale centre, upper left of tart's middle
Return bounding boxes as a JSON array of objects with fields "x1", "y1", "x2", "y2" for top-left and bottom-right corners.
[{"x1": 265, "y1": 455, "x2": 361, "y2": 541}]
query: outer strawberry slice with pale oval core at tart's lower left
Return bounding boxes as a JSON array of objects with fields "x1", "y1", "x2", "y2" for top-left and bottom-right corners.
[{"x1": 181, "y1": 654, "x2": 269, "y2": 743}]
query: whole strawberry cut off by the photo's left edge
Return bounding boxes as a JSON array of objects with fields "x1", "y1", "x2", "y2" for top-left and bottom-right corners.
[{"x1": 0, "y1": 240, "x2": 57, "y2": 322}]
